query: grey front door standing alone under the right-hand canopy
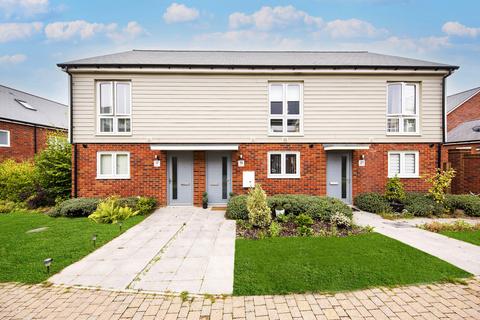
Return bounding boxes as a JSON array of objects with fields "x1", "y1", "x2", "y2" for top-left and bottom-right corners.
[{"x1": 327, "y1": 151, "x2": 352, "y2": 203}]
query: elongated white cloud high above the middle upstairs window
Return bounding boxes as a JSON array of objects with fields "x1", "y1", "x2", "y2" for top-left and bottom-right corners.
[{"x1": 228, "y1": 5, "x2": 323, "y2": 30}]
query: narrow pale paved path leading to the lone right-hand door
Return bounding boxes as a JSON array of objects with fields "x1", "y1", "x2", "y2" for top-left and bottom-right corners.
[{"x1": 354, "y1": 212, "x2": 480, "y2": 275}]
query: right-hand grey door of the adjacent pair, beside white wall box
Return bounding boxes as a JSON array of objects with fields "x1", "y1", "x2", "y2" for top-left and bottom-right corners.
[{"x1": 207, "y1": 151, "x2": 232, "y2": 204}]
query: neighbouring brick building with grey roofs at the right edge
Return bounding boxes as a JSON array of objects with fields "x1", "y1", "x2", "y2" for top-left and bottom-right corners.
[{"x1": 445, "y1": 87, "x2": 480, "y2": 194}]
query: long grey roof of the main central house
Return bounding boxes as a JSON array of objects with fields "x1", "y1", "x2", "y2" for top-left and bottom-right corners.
[{"x1": 58, "y1": 50, "x2": 458, "y2": 69}]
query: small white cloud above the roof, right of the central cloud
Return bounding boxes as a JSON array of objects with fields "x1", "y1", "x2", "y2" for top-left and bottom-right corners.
[{"x1": 323, "y1": 19, "x2": 388, "y2": 38}]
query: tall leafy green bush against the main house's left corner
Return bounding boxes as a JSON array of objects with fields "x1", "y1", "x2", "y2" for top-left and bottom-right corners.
[{"x1": 35, "y1": 133, "x2": 72, "y2": 201}]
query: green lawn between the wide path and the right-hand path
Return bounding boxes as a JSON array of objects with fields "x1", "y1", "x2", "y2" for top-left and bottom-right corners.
[{"x1": 234, "y1": 233, "x2": 470, "y2": 295}]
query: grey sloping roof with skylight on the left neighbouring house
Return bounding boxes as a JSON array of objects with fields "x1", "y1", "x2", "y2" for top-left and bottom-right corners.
[{"x1": 0, "y1": 85, "x2": 68, "y2": 129}]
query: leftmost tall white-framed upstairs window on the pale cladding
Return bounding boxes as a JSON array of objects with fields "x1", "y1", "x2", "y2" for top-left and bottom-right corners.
[{"x1": 97, "y1": 81, "x2": 132, "y2": 135}]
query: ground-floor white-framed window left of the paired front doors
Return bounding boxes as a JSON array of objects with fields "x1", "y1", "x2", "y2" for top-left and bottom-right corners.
[{"x1": 97, "y1": 151, "x2": 130, "y2": 179}]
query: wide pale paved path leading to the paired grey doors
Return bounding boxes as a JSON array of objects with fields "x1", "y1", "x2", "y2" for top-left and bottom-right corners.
[{"x1": 49, "y1": 207, "x2": 235, "y2": 294}]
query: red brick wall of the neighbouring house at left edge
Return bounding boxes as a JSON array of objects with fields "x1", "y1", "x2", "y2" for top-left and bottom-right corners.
[{"x1": 0, "y1": 121, "x2": 66, "y2": 162}]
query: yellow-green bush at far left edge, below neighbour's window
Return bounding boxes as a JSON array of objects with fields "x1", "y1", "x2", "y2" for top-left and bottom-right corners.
[{"x1": 0, "y1": 159, "x2": 35, "y2": 202}]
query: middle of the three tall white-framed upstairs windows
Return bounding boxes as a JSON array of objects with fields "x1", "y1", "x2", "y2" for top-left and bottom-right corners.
[{"x1": 268, "y1": 82, "x2": 303, "y2": 135}]
